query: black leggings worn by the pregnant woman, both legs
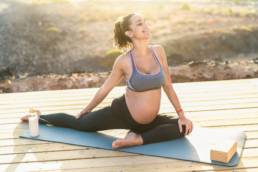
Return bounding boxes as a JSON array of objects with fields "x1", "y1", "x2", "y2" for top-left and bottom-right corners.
[{"x1": 39, "y1": 94, "x2": 184, "y2": 144}]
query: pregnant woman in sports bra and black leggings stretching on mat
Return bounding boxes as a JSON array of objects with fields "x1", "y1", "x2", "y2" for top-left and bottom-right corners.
[{"x1": 21, "y1": 13, "x2": 193, "y2": 149}]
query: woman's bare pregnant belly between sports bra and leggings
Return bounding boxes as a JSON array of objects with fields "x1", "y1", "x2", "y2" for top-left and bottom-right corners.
[{"x1": 125, "y1": 89, "x2": 161, "y2": 124}]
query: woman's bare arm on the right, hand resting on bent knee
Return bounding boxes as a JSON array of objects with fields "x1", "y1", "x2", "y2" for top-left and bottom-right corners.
[{"x1": 156, "y1": 45, "x2": 193, "y2": 134}]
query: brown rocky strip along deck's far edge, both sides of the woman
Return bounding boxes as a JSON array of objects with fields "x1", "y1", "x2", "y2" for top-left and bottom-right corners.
[{"x1": 0, "y1": 59, "x2": 258, "y2": 92}]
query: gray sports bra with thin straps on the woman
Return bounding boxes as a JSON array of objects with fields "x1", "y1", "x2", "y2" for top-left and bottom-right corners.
[{"x1": 127, "y1": 47, "x2": 164, "y2": 92}]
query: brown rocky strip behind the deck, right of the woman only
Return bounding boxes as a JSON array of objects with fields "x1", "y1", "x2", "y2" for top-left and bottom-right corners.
[{"x1": 170, "y1": 59, "x2": 258, "y2": 82}]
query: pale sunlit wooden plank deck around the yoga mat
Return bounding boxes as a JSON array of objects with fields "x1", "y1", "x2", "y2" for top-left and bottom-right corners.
[{"x1": 0, "y1": 78, "x2": 258, "y2": 172}]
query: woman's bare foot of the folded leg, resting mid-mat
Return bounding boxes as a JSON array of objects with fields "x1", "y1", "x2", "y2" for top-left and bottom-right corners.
[{"x1": 112, "y1": 132, "x2": 143, "y2": 149}]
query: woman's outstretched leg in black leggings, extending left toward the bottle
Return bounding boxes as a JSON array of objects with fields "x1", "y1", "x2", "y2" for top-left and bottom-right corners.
[{"x1": 39, "y1": 106, "x2": 127, "y2": 131}]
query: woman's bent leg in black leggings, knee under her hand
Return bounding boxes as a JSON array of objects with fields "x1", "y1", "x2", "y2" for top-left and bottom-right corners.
[{"x1": 136, "y1": 115, "x2": 184, "y2": 144}]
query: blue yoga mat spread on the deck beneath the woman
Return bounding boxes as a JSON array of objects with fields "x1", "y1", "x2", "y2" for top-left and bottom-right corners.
[{"x1": 20, "y1": 124, "x2": 246, "y2": 166}]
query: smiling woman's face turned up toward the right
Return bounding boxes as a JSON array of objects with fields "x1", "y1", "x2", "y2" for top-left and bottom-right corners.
[{"x1": 128, "y1": 14, "x2": 151, "y2": 40}]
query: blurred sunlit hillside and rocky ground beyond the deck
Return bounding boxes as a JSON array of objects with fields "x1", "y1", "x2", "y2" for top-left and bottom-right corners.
[{"x1": 0, "y1": 0, "x2": 258, "y2": 93}]
